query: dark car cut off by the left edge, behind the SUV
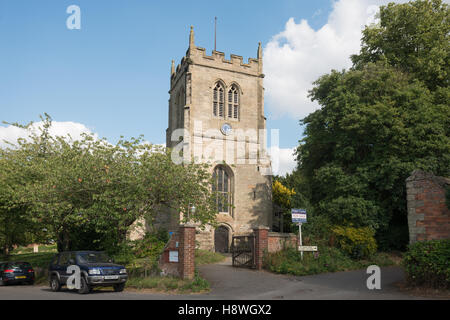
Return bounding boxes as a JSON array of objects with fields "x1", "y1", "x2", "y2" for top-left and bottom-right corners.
[{"x1": 0, "y1": 262, "x2": 34, "y2": 286}]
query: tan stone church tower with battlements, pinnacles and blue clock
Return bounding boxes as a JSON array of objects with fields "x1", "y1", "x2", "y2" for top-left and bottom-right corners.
[{"x1": 166, "y1": 27, "x2": 272, "y2": 252}]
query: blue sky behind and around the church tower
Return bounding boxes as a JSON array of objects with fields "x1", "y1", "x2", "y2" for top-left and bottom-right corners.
[{"x1": 0, "y1": 0, "x2": 406, "y2": 175}]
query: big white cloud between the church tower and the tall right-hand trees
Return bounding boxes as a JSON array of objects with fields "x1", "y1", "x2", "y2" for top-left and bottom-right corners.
[{"x1": 264, "y1": 0, "x2": 405, "y2": 118}]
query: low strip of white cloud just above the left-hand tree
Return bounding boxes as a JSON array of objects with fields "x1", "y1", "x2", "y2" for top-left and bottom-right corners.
[{"x1": 0, "y1": 121, "x2": 98, "y2": 148}]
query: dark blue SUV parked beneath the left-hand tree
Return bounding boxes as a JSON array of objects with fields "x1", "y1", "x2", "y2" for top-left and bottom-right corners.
[{"x1": 48, "y1": 251, "x2": 128, "y2": 294}]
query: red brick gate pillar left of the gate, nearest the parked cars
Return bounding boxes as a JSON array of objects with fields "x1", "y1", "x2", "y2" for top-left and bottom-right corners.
[{"x1": 178, "y1": 225, "x2": 195, "y2": 279}]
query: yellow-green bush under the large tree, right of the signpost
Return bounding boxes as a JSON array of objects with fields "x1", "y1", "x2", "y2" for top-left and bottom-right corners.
[{"x1": 332, "y1": 226, "x2": 377, "y2": 259}]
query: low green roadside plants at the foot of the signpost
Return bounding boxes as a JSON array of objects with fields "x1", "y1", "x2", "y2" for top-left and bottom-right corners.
[{"x1": 264, "y1": 246, "x2": 395, "y2": 276}]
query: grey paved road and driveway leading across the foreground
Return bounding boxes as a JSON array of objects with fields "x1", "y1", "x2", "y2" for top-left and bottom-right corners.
[{"x1": 0, "y1": 260, "x2": 426, "y2": 300}]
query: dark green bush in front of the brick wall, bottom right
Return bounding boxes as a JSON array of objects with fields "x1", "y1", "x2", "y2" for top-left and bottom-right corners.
[{"x1": 403, "y1": 239, "x2": 450, "y2": 288}]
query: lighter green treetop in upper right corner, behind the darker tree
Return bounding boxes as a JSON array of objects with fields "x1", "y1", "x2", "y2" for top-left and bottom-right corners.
[{"x1": 352, "y1": 0, "x2": 450, "y2": 90}]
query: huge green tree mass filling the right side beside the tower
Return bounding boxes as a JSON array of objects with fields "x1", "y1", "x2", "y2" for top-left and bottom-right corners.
[{"x1": 297, "y1": 1, "x2": 450, "y2": 248}]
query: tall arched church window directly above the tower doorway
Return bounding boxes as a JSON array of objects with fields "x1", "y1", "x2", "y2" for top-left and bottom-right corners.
[{"x1": 213, "y1": 166, "x2": 233, "y2": 213}]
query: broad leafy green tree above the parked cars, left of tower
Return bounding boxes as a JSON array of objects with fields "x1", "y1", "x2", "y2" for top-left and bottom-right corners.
[{"x1": 0, "y1": 117, "x2": 215, "y2": 250}]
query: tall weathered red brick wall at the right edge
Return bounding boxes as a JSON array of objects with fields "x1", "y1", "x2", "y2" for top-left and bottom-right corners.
[{"x1": 406, "y1": 170, "x2": 450, "y2": 243}]
